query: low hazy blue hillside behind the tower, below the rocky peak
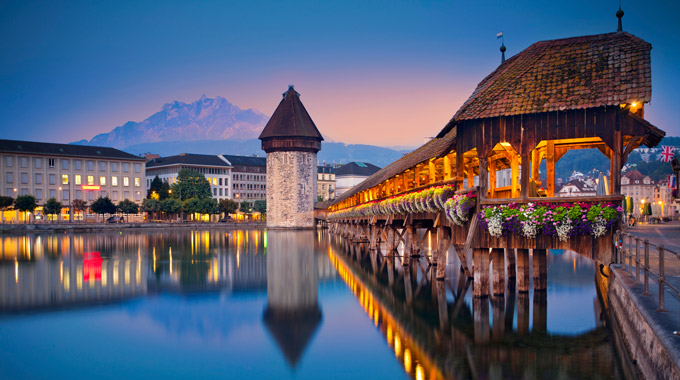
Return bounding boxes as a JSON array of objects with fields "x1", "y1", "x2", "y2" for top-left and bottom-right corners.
[{"x1": 123, "y1": 139, "x2": 405, "y2": 167}]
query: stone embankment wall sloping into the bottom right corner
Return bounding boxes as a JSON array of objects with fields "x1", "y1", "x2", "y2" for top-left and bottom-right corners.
[{"x1": 608, "y1": 267, "x2": 680, "y2": 379}]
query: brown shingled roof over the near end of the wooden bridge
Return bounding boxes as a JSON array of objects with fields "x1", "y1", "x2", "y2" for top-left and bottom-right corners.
[{"x1": 453, "y1": 32, "x2": 652, "y2": 120}]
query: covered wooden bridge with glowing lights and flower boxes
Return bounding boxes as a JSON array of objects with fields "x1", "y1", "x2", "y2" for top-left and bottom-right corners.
[{"x1": 328, "y1": 32, "x2": 665, "y2": 296}]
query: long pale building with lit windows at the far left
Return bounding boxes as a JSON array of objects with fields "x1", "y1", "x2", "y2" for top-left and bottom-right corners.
[{"x1": 0, "y1": 140, "x2": 146, "y2": 220}]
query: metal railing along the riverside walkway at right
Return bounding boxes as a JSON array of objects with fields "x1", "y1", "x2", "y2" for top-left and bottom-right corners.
[{"x1": 614, "y1": 231, "x2": 680, "y2": 335}]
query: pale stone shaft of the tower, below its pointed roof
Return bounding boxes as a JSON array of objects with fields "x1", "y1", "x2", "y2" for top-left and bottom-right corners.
[{"x1": 267, "y1": 151, "x2": 316, "y2": 228}]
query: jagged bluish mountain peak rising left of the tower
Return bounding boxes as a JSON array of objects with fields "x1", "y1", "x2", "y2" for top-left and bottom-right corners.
[{"x1": 76, "y1": 95, "x2": 269, "y2": 149}]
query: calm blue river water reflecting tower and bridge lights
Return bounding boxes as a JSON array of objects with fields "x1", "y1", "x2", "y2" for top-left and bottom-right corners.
[{"x1": 0, "y1": 230, "x2": 623, "y2": 379}]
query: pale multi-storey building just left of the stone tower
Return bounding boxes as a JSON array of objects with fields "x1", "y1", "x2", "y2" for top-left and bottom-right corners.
[{"x1": 221, "y1": 154, "x2": 267, "y2": 203}]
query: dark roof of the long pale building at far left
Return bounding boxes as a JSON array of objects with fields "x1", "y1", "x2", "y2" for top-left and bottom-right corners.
[{"x1": 0, "y1": 140, "x2": 145, "y2": 161}]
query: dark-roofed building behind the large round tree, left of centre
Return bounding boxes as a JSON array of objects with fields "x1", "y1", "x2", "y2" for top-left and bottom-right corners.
[{"x1": 146, "y1": 153, "x2": 233, "y2": 201}]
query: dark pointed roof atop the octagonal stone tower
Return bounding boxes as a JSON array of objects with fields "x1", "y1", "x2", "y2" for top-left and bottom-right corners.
[{"x1": 259, "y1": 86, "x2": 323, "y2": 141}]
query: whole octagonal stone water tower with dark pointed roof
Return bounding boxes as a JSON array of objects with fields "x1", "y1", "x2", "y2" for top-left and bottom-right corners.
[{"x1": 259, "y1": 86, "x2": 323, "y2": 228}]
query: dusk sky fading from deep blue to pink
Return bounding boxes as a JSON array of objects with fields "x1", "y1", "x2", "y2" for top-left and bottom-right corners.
[{"x1": 0, "y1": 0, "x2": 680, "y2": 146}]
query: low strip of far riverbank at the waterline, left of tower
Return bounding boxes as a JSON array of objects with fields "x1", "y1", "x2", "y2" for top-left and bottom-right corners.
[{"x1": 0, "y1": 222, "x2": 267, "y2": 234}]
